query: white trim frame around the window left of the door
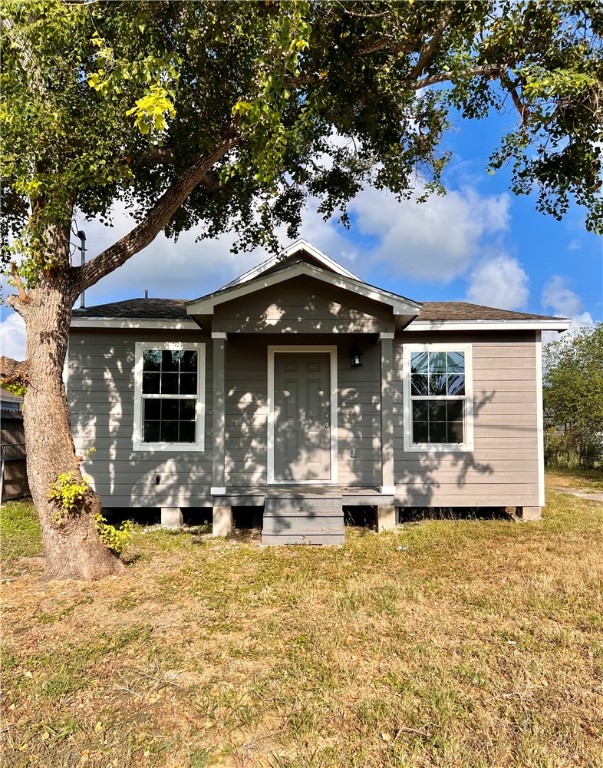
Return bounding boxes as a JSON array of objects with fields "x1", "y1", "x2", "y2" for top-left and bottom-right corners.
[{"x1": 132, "y1": 341, "x2": 205, "y2": 453}]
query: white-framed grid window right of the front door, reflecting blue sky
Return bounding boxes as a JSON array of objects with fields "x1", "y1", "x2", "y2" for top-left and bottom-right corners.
[{"x1": 404, "y1": 344, "x2": 473, "y2": 451}]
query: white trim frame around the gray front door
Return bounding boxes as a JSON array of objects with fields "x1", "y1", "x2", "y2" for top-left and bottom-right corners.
[{"x1": 267, "y1": 344, "x2": 338, "y2": 485}]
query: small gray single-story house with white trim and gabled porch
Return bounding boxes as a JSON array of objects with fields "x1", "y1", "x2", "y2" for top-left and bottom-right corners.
[{"x1": 67, "y1": 240, "x2": 568, "y2": 544}]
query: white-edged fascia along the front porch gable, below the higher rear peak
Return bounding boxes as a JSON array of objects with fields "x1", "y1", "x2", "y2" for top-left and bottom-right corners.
[{"x1": 186, "y1": 263, "x2": 420, "y2": 315}]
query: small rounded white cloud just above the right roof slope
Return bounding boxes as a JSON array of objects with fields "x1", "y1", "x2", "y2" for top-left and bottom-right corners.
[{"x1": 467, "y1": 254, "x2": 530, "y2": 309}]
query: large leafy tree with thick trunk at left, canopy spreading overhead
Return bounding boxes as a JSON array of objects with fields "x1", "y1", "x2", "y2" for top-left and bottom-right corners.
[{"x1": 0, "y1": 0, "x2": 603, "y2": 577}]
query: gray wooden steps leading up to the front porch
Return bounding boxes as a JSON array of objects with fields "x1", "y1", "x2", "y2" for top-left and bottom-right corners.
[{"x1": 262, "y1": 493, "x2": 344, "y2": 546}]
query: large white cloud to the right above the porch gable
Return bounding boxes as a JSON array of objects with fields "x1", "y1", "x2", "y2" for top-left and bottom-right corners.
[{"x1": 350, "y1": 187, "x2": 510, "y2": 283}]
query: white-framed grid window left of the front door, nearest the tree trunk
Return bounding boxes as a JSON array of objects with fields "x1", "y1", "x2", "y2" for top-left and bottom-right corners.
[{"x1": 134, "y1": 342, "x2": 205, "y2": 451}]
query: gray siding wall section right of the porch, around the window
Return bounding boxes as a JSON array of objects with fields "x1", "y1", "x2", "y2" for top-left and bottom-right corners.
[{"x1": 393, "y1": 332, "x2": 540, "y2": 507}]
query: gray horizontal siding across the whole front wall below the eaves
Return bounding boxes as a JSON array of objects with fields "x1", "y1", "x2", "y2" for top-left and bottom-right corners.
[{"x1": 68, "y1": 324, "x2": 539, "y2": 507}]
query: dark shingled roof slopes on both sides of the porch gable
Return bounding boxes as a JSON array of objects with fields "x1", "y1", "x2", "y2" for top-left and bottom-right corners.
[{"x1": 73, "y1": 299, "x2": 555, "y2": 321}]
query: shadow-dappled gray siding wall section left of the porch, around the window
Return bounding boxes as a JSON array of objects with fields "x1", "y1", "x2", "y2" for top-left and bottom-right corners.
[{"x1": 67, "y1": 329, "x2": 212, "y2": 507}]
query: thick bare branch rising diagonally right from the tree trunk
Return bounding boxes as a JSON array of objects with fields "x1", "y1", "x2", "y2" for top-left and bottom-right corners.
[{"x1": 77, "y1": 137, "x2": 239, "y2": 293}]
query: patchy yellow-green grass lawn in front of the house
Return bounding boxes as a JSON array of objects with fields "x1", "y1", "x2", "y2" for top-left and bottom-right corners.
[{"x1": 2, "y1": 478, "x2": 603, "y2": 768}]
